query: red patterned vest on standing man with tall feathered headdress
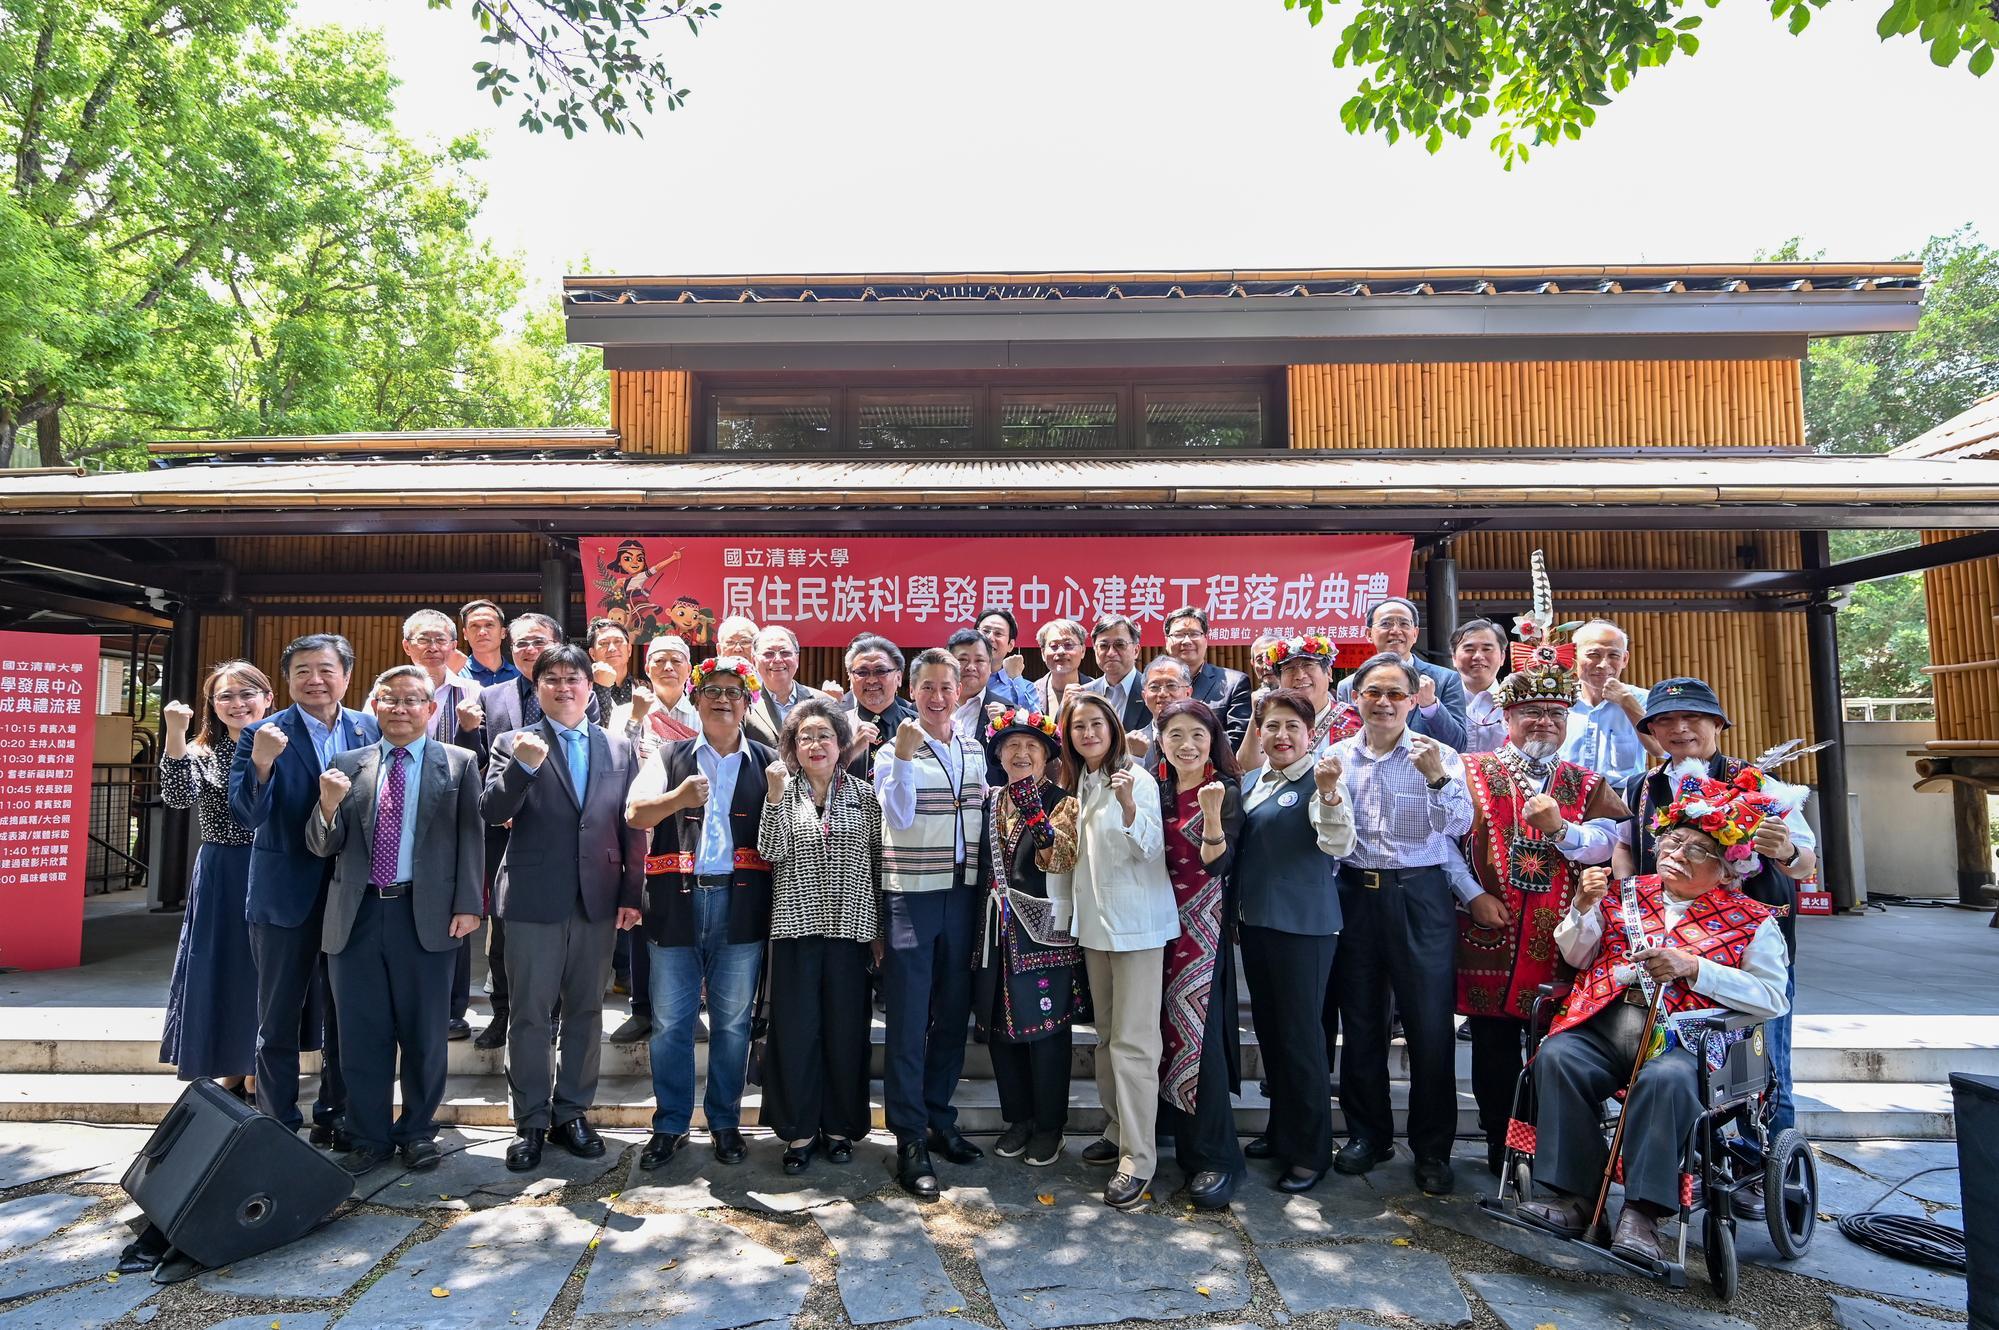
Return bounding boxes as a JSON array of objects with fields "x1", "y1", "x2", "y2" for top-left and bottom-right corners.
[{"x1": 1457, "y1": 752, "x2": 1603, "y2": 1020}]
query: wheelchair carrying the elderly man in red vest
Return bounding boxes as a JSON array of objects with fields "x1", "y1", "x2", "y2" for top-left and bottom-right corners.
[{"x1": 1479, "y1": 984, "x2": 1819, "y2": 1300}]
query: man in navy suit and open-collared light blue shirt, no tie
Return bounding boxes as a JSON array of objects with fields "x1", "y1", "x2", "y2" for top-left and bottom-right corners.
[{"x1": 230, "y1": 632, "x2": 382, "y2": 1150}]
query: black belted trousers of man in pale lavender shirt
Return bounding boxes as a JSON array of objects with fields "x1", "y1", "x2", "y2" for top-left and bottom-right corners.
[{"x1": 1339, "y1": 868, "x2": 1457, "y2": 1160}]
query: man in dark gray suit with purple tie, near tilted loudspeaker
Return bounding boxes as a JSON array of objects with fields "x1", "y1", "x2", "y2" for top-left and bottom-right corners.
[{"x1": 306, "y1": 664, "x2": 486, "y2": 1174}]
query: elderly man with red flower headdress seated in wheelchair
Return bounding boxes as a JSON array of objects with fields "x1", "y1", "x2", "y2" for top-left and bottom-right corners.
[{"x1": 1519, "y1": 768, "x2": 1789, "y2": 1262}]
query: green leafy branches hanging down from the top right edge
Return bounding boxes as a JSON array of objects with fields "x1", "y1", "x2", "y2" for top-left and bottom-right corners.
[{"x1": 1283, "y1": 0, "x2": 1999, "y2": 170}]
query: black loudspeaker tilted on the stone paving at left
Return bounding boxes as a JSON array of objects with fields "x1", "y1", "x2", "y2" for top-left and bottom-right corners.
[{"x1": 124, "y1": 1080, "x2": 354, "y2": 1268}]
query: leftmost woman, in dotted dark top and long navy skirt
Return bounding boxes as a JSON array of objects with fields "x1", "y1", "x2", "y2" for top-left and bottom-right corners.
[{"x1": 160, "y1": 660, "x2": 272, "y2": 1094}]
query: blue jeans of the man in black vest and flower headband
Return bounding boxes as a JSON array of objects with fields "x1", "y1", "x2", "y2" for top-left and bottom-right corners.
[{"x1": 646, "y1": 886, "x2": 764, "y2": 1136}]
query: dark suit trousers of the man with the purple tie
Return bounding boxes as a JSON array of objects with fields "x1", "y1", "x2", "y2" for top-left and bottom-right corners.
[{"x1": 326, "y1": 894, "x2": 464, "y2": 1150}]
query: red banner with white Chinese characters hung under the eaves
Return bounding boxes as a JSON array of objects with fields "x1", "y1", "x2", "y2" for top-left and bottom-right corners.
[{"x1": 582, "y1": 536, "x2": 1411, "y2": 658}]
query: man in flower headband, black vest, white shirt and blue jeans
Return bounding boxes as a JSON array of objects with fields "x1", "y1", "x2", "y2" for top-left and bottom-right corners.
[{"x1": 624, "y1": 656, "x2": 778, "y2": 1172}]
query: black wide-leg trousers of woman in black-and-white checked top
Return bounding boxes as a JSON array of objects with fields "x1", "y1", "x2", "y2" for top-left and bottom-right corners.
[{"x1": 759, "y1": 938, "x2": 874, "y2": 1142}]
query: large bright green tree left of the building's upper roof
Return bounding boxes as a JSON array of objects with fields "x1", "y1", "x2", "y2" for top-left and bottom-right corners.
[{"x1": 0, "y1": 0, "x2": 602, "y2": 466}]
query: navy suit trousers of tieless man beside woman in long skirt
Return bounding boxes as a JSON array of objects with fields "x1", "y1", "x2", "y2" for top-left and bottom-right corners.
[{"x1": 250, "y1": 900, "x2": 348, "y2": 1132}]
